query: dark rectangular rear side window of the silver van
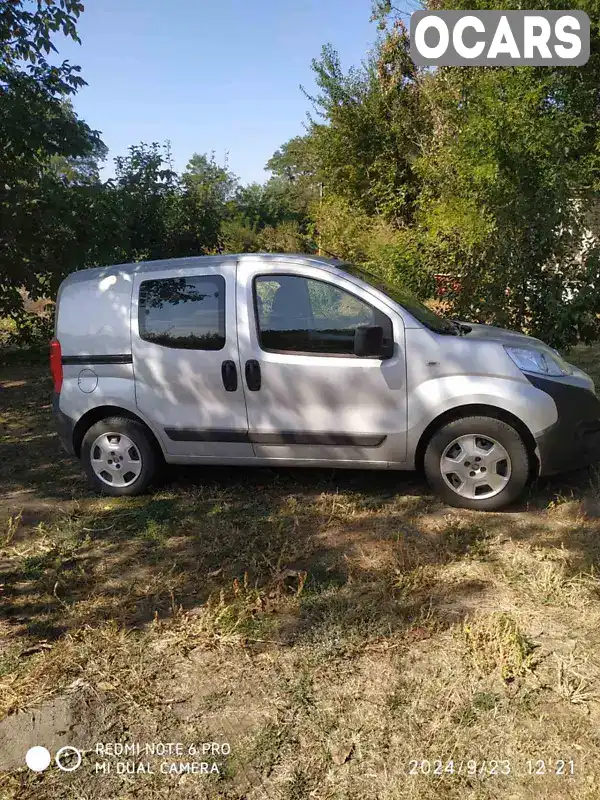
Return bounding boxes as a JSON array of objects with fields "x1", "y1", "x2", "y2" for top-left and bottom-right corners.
[{"x1": 138, "y1": 275, "x2": 225, "y2": 350}]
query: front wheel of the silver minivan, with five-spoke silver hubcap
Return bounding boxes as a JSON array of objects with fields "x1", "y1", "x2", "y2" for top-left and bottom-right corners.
[{"x1": 423, "y1": 417, "x2": 532, "y2": 511}]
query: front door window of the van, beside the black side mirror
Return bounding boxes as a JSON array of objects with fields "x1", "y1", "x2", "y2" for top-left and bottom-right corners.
[{"x1": 254, "y1": 275, "x2": 392, "y2": 355}]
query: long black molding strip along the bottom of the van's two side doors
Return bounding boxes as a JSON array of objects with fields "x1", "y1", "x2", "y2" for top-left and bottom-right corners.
[{"x1": 165, "y1": 428, "x2": 386, "y2": 447}]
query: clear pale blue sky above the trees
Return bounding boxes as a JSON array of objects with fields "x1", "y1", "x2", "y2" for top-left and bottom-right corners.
[{"x1": 56, "y1": 0, "x2": 377, "y2": 183}]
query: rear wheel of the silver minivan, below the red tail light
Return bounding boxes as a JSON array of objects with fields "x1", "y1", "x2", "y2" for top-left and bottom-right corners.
[{"x1": 80, "y1": 417, "x2": 160, "y2": 497}]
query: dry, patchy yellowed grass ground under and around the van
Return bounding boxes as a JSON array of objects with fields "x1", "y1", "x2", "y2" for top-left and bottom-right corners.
[{"x1": 0, "y1": 348, "x2": 600, "y2": 800}]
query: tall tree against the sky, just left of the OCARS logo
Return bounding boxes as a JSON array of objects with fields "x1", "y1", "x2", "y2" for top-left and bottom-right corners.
[{"x1": 308, "y1": 37, "x2": 423, "y2": 226}]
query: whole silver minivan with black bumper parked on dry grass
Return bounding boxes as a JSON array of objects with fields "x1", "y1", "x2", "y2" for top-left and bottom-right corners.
[{"x1": 50, "y1": 254, "x2": 600, "y2": 510}]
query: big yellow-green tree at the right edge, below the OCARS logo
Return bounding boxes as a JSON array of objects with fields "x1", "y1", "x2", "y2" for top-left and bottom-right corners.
[{"x1": 417, "y1": 2, "x2": 600, "y2": 347}]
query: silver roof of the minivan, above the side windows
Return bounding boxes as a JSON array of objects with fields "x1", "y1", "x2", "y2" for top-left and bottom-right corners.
[{"x1": 64, "y1": 253, "x2": 344, "y2": 284}]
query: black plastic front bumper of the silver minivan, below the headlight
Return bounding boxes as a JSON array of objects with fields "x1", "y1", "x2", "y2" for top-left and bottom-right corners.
[{"x1": 527, "y1": 375, "x2": 600, "y2": 475}]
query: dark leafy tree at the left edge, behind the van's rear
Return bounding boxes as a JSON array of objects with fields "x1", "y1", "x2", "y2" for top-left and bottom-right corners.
[{"x1": 0, "y1": 0, "x2": 104, "y2": 318}]
